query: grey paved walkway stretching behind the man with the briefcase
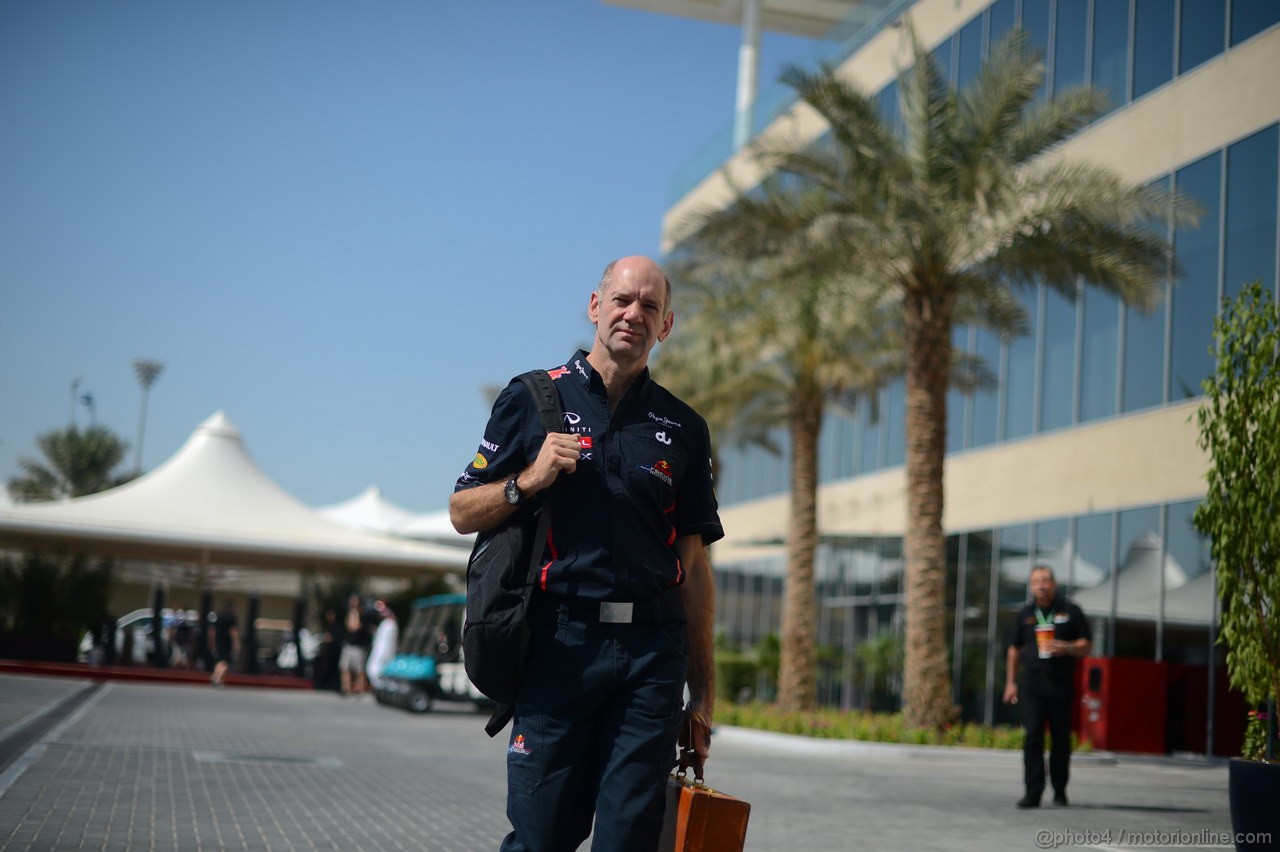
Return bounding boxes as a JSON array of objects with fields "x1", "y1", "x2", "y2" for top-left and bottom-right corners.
[{"x1": 0, "y1": 675, "x2": 1230, "y2": 852}]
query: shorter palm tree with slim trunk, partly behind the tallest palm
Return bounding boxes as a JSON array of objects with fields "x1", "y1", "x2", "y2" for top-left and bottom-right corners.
[{"x1": 675, "y1": 182, "x2": 900, "y2": 710}]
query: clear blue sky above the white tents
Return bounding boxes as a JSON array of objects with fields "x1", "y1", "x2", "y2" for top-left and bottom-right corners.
[{"x1": 0, "y1": 0, "x2": 809, "y2": 512}]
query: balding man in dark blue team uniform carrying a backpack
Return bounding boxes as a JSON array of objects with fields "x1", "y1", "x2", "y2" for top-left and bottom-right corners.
[{"x1": 449, "y1": 257, "x2": 723, "y2": 852}]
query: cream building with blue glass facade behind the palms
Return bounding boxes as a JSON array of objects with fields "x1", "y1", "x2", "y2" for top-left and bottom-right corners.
[{"x1": 664, "y1": 0, "x2": 1280, "y2": 751}]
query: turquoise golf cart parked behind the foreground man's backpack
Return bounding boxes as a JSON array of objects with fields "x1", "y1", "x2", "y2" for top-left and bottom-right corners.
[{"x1": 374, "y1": 595, "x2": 492, "y2": 713}]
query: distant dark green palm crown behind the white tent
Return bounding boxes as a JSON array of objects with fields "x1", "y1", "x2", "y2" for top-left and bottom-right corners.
[{"x1": 9, "y1": 426, "x2": 132, "y2": 503}]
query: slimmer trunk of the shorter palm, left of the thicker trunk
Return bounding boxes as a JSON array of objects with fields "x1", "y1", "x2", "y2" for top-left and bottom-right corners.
[{"x1": 777, "y1": 393, "x2": 824, "y2": 710}]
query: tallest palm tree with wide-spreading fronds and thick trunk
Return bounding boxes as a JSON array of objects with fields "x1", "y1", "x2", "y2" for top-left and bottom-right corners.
[{"x1": 675, "y1": 28, "x2": 1194, "y2": 727}]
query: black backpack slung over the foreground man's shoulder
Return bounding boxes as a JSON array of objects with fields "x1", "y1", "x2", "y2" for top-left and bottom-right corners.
[{"x1": 462, "y1": 370, "x2": 564, "y2": 737}]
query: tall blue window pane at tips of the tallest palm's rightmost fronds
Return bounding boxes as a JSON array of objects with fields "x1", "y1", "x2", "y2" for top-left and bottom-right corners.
[{"x1": 1169, "y1": 154, "x2": 1222, "y2": 400}]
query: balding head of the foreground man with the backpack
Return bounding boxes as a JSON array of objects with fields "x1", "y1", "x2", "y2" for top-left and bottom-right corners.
[{"x1": 586, "y1": 265, "x2": 673, "y2": 361}]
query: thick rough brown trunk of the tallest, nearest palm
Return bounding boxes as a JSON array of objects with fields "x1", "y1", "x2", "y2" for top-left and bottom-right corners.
[{"x1": 902, "y1": 290, "x2": 956, "y2": 728}]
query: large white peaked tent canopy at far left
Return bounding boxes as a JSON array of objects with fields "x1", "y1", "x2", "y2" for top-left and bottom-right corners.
[{"x1": 0, "y1": 412, "x2": 467, "y2": 574}]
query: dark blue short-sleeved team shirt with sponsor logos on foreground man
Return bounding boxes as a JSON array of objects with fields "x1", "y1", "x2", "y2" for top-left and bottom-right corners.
[{"x1": 453, "y1": 349, "x2": 724, "y2": 601}]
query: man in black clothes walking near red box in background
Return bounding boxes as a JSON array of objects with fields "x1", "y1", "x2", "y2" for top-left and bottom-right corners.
[{"x1": 1005, "y1": 565, "x2": 1093, "y2": 807}]
